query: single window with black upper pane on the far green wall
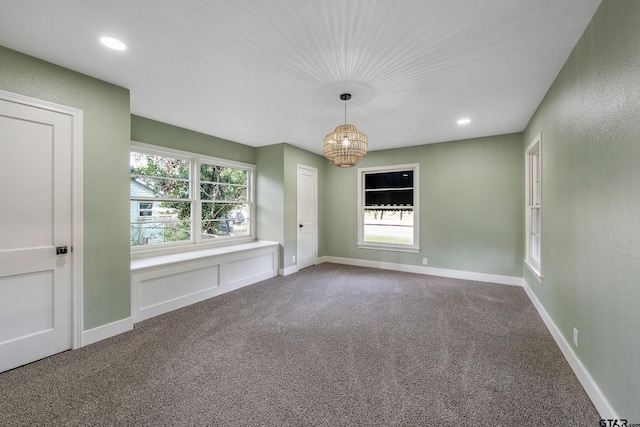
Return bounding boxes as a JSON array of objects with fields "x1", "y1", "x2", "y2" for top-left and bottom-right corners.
[{"x1": 358, "y1": 164, "x2": 420, "y2": 252}]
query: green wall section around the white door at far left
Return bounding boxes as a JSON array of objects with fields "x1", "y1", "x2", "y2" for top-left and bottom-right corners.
[{"x1": 0, "y1": 46, "x2": 131, "y2": 330}]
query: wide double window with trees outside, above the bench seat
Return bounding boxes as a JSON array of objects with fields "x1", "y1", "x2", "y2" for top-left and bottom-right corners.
[{"x1": 130, "y1": 143, "x2": 254, "y2": 249}]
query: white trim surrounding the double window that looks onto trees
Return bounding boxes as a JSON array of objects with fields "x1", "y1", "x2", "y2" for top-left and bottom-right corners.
[{"x1": 130, "y1": 141, "x2": 256, "y2": 259}]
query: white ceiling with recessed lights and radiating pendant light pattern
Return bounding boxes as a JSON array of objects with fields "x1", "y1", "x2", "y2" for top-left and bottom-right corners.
[{"x1": 0, "y1": 0, "x2": 601, "y2": 153}]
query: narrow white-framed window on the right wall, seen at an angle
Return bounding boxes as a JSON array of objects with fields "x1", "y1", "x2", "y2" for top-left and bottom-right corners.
[{"x1": 525, "y1": 135, "x2": 542, "y2": 279}]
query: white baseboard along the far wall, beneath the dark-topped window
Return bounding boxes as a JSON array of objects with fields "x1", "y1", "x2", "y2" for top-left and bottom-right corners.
[{"x1": 318, "y1": 256, "x2": 522, "y2": 286}]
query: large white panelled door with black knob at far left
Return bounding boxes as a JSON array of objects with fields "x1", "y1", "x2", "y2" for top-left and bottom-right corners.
[{"x1": 0, "y1": 94, "x2": 73, "y2": 372}]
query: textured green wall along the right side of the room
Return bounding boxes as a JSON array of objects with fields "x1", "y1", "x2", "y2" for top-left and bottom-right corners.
[{"x1": 523, "y1": 0, "x2": 640, "y2": 423}]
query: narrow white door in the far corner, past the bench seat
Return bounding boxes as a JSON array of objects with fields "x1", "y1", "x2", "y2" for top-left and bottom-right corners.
[{"x1": 297, "y1": 165, "x2": 318, "y2": 269}]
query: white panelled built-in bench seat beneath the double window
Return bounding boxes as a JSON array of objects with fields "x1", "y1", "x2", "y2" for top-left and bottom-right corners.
[{"x1": 131, "y1": 241, "x2": 279, "y2": 323}]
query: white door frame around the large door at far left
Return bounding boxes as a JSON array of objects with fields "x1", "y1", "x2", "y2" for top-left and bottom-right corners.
[{"x1": 0, "y1": 90, "x2": 84, "y2": 349}]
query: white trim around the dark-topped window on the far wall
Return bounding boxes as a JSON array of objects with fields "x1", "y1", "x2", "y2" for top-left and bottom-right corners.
[{"x1": 358, "y1": 163, "x2": 420, "y2": 253}]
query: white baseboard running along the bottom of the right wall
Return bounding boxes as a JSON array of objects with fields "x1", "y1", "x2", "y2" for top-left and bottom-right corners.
[{"x1": 522, "y1": 280, "x2": 618, "y2": 419}]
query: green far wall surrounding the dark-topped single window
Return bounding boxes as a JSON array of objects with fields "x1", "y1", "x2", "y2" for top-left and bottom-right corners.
[{"x1": 325, "y1": 134, "x2": 524, "y2": 277}]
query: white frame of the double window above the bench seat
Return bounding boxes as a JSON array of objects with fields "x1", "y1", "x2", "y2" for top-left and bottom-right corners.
[{"x1": 129, "y1": 141, "x2": 256, "y2": 257}]
